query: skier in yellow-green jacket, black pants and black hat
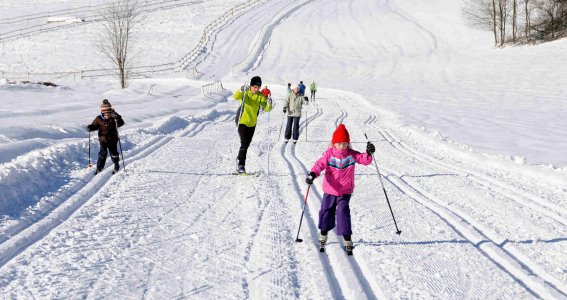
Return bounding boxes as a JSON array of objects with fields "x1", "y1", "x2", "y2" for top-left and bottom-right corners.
[{"x1": 232, "y1": 76, "x2": 272, "y2": 174}]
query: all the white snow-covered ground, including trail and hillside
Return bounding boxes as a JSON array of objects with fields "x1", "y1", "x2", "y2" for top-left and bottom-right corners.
[{"x1": 0, "y1": 0, "x2": 567, "y2": 299}]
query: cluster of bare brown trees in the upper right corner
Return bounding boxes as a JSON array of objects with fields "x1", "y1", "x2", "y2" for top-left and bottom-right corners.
[{"x1": 462, "y1": 0, "x2": 567, "y2": 47}]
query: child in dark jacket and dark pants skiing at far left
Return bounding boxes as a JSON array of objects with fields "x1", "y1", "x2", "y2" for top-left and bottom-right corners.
[{"x1": 87, "y1": 99, "x2": 124, "y2": 175}]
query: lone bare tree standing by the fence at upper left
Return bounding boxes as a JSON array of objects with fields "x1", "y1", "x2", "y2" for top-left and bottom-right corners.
[{"x1": 98, "y1": 0, "x2": 142, "y2": 89}]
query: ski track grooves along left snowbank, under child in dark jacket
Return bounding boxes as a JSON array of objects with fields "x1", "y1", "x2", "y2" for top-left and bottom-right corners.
[{"x1": 0, "y1": 111, "x2": 233, "y2": 268}]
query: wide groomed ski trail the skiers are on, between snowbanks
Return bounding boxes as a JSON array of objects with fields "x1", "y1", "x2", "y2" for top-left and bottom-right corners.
[{"x1": 0, "y1": 91, "x2": 566, "y2": 299}]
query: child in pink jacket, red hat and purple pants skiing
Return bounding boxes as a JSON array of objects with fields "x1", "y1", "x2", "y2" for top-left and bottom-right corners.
[{"x1": 305, "y1": 124, "x2": 376, "y2": 252}]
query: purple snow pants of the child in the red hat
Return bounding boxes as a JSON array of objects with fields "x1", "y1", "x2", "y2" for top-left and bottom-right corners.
[{"x1": 319, "y1": 193, "x2": 352, "y2": 235}]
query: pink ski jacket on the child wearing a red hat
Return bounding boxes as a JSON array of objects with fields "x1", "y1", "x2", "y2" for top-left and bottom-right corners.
[{"x1": 311, "y1": 147, "x2": 372, "y2": 196}]
